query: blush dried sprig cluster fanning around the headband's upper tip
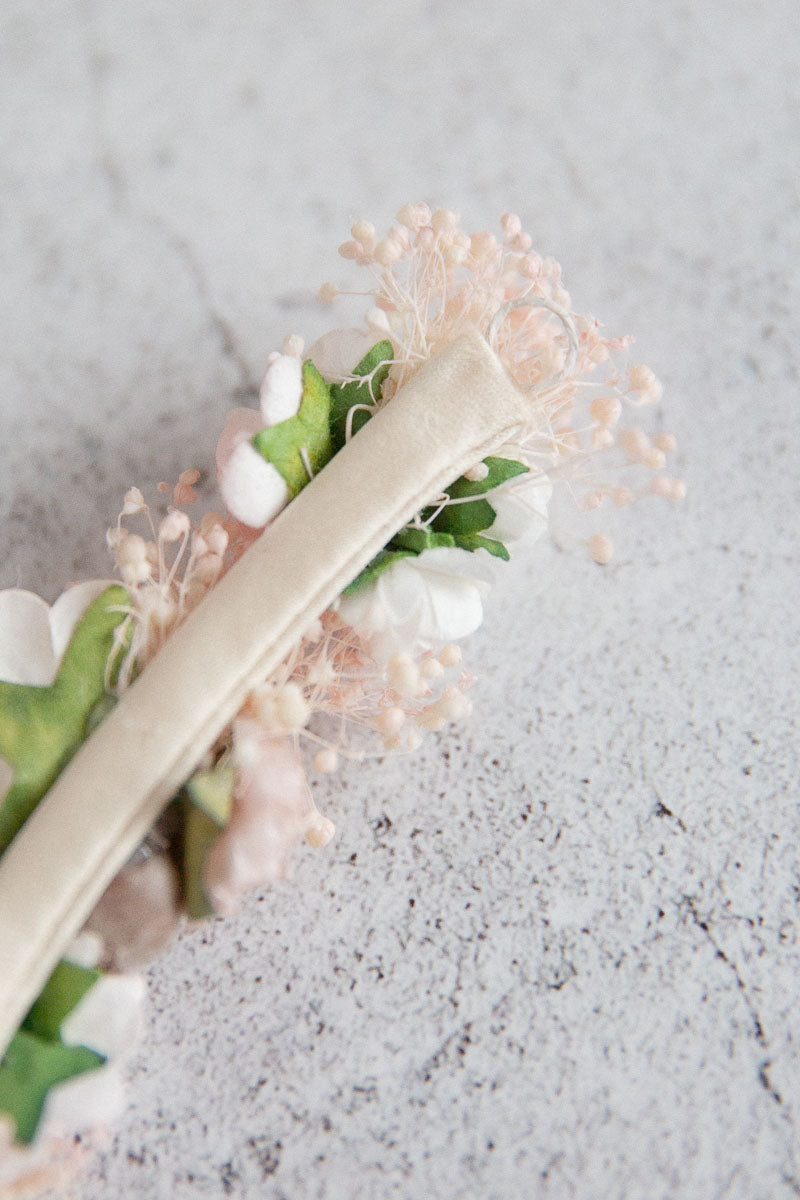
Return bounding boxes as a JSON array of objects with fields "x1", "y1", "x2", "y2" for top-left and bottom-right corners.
[{"x1": 319, "y1": 203, "x2": 685, "y2": 563}]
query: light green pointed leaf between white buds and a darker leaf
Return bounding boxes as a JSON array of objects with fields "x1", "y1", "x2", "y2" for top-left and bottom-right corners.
[{"x1": 253, "y1": 360, "x2": 333, "y2": 499}]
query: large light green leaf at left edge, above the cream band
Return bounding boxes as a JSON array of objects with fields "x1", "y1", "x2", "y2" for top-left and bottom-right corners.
[{"x1": 0, "y1": 586, "x2": 130, "y2": 854}]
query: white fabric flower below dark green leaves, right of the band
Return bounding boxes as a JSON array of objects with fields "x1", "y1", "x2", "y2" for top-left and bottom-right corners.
[{"x1": 338, "y1": 546, "x2": 493, "y2": 662}]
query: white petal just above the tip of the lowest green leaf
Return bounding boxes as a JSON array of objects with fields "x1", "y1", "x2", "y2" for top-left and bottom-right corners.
[{"x1": 61, "y1": 974, "x2": 145, "y2": 1058}]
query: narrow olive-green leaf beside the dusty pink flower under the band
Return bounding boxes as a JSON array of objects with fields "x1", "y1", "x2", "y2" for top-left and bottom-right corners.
[{"x1": 182, "y1": 767, "x2": 234, "y2": 920}]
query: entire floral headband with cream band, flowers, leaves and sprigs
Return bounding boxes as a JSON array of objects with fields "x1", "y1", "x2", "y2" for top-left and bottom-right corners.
[{"x1": 0, "y1": 204, "x2": 684, "y2": 1194}]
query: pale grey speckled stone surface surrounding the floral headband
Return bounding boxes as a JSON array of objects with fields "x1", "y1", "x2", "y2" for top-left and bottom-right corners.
[{"x1": 0, "y1": 0, "x2": 800, "y2": 1200}]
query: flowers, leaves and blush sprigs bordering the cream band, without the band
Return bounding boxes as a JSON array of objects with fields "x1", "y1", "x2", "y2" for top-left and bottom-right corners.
[{"x1": 0, "y1": 204, "x2": 684, "y2": 1189}]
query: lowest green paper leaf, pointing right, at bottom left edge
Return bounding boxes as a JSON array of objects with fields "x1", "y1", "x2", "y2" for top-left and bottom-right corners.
[{"x1": 0, "y1": 1030, "x2": 106, "y2": 1142}]
